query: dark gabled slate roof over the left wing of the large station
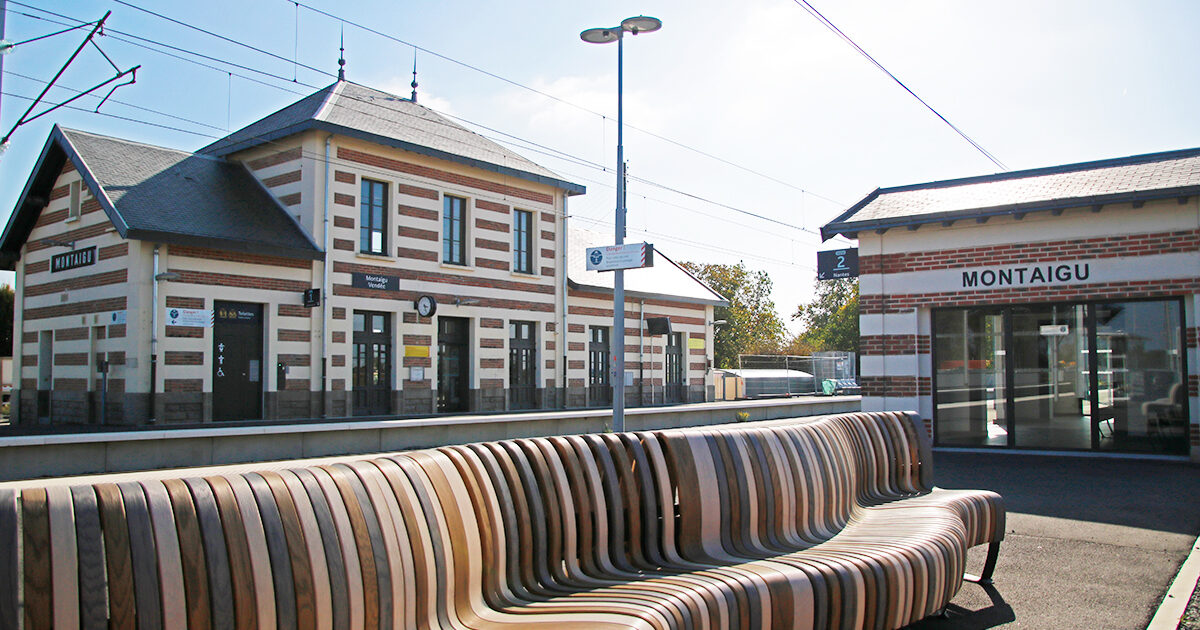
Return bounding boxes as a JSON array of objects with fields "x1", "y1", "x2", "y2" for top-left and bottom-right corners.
[{"x1": 0, "y1": 126, "x2": 322, "y2": 269}]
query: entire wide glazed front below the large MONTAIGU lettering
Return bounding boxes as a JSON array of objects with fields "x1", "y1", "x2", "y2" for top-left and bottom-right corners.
[{"x1": 934, "y1": 299, "x2": 1188, "y2": 455}]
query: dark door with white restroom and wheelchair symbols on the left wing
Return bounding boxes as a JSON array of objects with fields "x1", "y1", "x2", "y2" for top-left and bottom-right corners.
[{"x1": 212, "y1": 301, "x2": 263, "y2": 420}]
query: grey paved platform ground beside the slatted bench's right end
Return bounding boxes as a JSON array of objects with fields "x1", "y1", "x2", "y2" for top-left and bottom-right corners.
[{"x1": 910, "y1": 452, "x2": 1200, "y2": 630}]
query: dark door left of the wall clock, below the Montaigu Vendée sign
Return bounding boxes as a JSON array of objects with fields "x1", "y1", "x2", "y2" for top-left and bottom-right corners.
[{"x1": 353, "y1": 311, "x2": 391, "y2": 415}]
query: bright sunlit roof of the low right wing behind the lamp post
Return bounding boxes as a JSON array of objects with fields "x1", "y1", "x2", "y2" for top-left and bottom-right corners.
[{"x1": 566, "y1": 227, "x2": 730, "y2": 306}]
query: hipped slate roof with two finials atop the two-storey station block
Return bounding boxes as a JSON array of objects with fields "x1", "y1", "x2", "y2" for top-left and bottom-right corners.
[{"x1": 199, "y1": 80, "x2": 584, "y2": 194}]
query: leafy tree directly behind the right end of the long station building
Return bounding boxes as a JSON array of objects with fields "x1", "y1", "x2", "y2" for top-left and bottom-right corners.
[{"x1": 683, "y1": 263, "x2": 784, "y2": 368}]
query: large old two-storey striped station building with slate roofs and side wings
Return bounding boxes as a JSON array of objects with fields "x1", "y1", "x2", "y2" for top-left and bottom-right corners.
[{"x1": 0, "y1": 80, "x2": 725, "y2": 425}]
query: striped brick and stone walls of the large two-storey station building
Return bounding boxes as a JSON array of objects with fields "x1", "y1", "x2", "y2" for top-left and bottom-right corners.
[{"x1": 6, "y1": 79, "x2": 713, "y2": 425}]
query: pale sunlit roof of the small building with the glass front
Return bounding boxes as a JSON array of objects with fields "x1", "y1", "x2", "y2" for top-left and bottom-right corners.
[{"x1": 821, "y1": 149, "x2": 1200, "y2": 239}]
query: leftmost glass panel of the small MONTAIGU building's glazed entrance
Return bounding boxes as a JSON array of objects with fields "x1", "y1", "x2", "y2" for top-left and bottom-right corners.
[{"x1": 934, "y1": 308, "x2": 1008, "y2": 446}]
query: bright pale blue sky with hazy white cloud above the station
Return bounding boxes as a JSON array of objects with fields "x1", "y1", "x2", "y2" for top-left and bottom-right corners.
[{"x1": 0, "y1": 0, "x2": 1200, "y2": 331}]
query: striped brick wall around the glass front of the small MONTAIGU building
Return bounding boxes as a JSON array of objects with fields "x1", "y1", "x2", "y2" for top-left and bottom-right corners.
[{"x1": 858, "y1": 197, "x2": 1200, "y2": 460}]
